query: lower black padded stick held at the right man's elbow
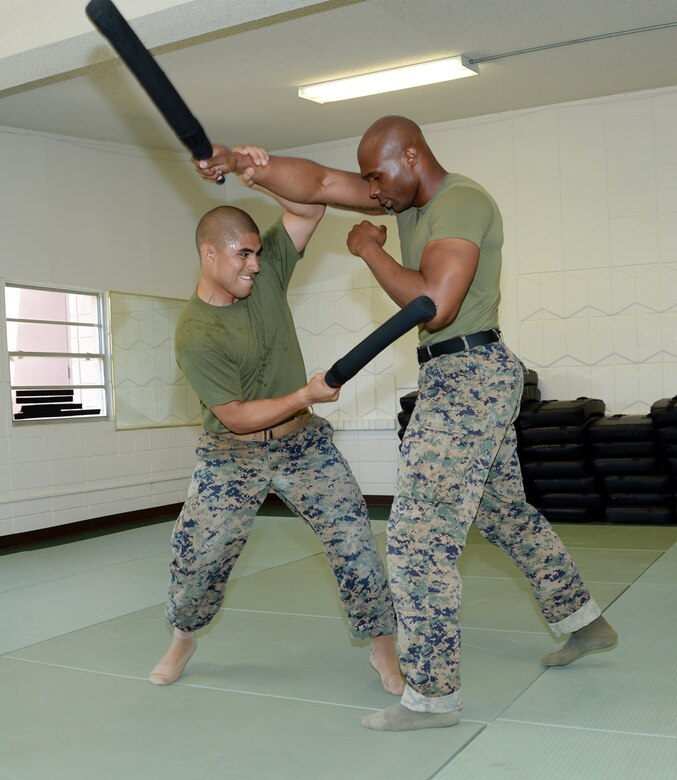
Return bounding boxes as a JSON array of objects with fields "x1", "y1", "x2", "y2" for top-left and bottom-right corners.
[{"x1": 324, "y1": 295, "x2": 437, "y2": 387}]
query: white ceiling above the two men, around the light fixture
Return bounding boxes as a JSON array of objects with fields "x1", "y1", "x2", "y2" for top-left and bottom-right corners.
[{"x1": 0, "y1": 0, "x2": 677, "y2": 155}]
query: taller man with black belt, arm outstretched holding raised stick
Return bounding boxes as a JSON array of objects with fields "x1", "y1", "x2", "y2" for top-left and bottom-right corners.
[{"x1": 196, "y1": 116, "x2": 617, "y2": 731}]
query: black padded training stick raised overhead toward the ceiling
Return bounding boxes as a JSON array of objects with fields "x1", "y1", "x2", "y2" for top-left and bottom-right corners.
[{"x1": 85, "y1": 0, "x2": 225, "y2": 184}]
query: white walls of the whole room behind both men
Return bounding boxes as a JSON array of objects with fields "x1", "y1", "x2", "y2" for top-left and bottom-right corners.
[{"x1": 0, "y1": 88, "x2": 677, "y2": 534}]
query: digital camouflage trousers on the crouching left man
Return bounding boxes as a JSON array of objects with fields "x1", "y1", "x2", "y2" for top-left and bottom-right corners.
[{"x1": 167, "y1": 416, "x2": 396, "y2": 639}]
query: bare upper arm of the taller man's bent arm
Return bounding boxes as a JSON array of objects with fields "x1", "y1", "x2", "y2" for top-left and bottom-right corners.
[{"x1": 419, "y1": 238, "x2": 480, "y2": 329}]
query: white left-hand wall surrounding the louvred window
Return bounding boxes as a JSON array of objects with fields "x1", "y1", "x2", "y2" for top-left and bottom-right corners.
[{"x1": 0, "y1": 128, "x2": 219, "y2": 535}]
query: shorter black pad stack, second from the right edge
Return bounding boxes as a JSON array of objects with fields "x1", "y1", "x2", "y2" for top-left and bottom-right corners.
[{"x1": 588, "y1": 414, "x2": 674, "y2": 524}]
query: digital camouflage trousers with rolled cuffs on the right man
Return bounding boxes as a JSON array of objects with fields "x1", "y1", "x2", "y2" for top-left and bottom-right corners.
[{"x1": 388, "y1": 341, "x2": 600, "y2": 712}]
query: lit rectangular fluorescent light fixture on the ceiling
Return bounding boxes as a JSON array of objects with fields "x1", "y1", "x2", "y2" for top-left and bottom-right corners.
[{"x1": 299, "y1": 56, "x2": 479, "y2": 103}]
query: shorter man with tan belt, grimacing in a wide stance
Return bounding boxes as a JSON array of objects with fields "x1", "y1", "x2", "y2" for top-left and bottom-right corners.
[{"x1": 150, "y1": 199, "x2": 404, "y2": 695}]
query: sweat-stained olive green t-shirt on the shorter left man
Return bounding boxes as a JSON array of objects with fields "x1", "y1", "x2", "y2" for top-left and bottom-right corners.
[{"x1": 175, "y1": 218, "x2": 306, "y2": 433}]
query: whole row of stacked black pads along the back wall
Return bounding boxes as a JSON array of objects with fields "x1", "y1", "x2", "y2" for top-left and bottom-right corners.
[{"x1": 398, "y1": 376, "x2": 677, "y2": 524}]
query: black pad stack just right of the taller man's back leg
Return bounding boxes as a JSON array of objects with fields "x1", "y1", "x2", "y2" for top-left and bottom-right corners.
[{"x1": 516, "y1": 398, "x2": 606, "y2": 522}]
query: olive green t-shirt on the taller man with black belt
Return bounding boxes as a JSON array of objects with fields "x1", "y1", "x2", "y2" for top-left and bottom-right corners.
[{"x1": 397, "y1": 173, "x2": 503, "y2": 344}]
